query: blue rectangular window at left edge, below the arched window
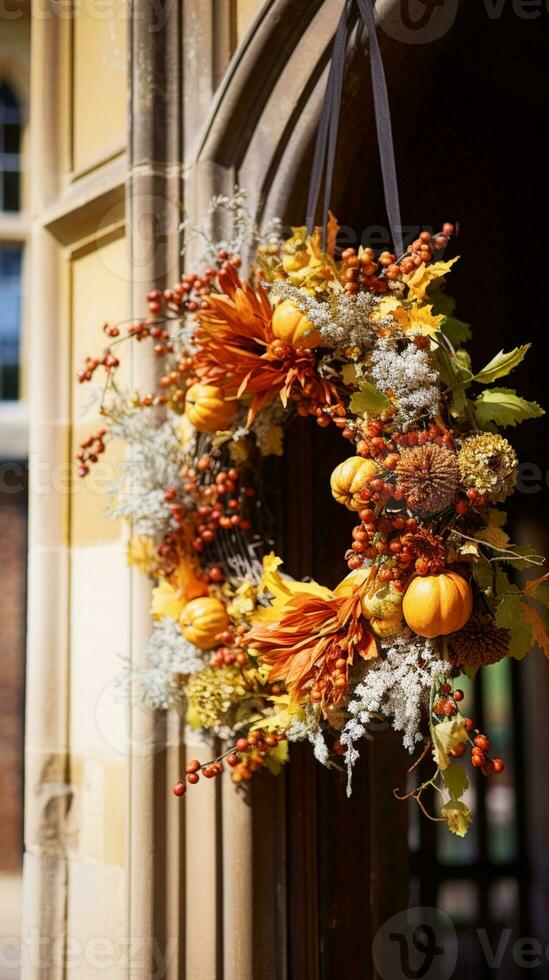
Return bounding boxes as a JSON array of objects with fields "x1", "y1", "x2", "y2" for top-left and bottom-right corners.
[{"x1": 0, "y1": 245, "x2": 22, "y2": 401}]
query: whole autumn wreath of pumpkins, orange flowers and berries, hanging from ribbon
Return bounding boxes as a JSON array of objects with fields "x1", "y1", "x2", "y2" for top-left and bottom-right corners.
[{"x1": 78, "y1": 191, "x2": 549, "y2": 836}]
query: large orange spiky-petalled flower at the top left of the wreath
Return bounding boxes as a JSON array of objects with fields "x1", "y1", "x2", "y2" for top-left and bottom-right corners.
[{"x1": 193, "y1": 269, "x2": 338, "y2": 424}]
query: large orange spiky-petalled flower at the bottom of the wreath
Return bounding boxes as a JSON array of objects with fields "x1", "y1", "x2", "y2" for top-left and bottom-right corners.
[{"x1": 247, "y1": 588, "x2": 377, "y2": 713}]
